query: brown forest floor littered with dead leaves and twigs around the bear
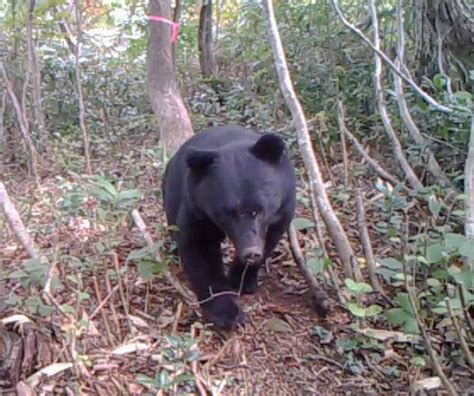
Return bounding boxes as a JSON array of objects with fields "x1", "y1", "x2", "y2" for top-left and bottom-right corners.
[{"x1": 0, "y1": 133, "x2": 473, "y2": 395}]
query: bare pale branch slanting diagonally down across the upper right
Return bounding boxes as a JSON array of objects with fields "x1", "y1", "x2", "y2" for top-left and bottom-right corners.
[{"x1": 332, "y1": 0, "x2": 453, "y2": 113}]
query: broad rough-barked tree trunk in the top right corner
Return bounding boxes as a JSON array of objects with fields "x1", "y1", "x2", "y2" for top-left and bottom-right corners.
[{"x1": 415, "y1": 0, "x2": 474, "y2": 79}]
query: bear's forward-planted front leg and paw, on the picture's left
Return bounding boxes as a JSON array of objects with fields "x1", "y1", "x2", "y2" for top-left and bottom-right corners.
[{"x1": 178, "y1": 238, "x2": 244, "y2": 330}]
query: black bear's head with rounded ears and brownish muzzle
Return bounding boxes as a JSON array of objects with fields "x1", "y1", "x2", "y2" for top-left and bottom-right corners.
[{"x1": 186, "y1": 134, "x2": 293, "y2": 264}]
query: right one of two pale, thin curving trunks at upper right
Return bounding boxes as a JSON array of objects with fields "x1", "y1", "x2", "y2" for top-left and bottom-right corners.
[{"x1": 393, "y1": 0, "x2": 453, "y2": 189}]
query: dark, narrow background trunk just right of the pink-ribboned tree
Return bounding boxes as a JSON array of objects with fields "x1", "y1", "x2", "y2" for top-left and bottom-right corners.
[{"x1": 198, "y1": 0, "x2": 215, "y2": 77}]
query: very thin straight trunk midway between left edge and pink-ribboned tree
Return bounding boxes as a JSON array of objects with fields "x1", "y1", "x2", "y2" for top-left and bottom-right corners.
[{"x1": 74, "y1": 0, "x2": 92, "y2": 174}]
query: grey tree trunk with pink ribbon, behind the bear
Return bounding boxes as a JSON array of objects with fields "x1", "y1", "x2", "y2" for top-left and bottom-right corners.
[{"x1": 148, "y1": 0, "x2": 193, "y2": 154}]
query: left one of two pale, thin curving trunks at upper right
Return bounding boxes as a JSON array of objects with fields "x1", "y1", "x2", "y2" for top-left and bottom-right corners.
[{"x1": 370, "y1": 0, "x2": 423, "y2": 189}]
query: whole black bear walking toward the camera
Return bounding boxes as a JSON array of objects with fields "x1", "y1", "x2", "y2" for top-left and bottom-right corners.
[{"x1": 162, "y1": 126, "x2": 296, "y2": 329}]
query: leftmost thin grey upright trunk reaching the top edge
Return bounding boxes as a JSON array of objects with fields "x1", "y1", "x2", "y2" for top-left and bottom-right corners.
[{"x1": 26, "y1": 0, "x2": 46, "y2": 142}]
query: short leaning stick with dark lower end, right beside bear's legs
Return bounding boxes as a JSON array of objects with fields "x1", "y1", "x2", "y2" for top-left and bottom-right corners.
[{"x1": 288, "y1": 225, "x2": 330, "y2": 317}]
